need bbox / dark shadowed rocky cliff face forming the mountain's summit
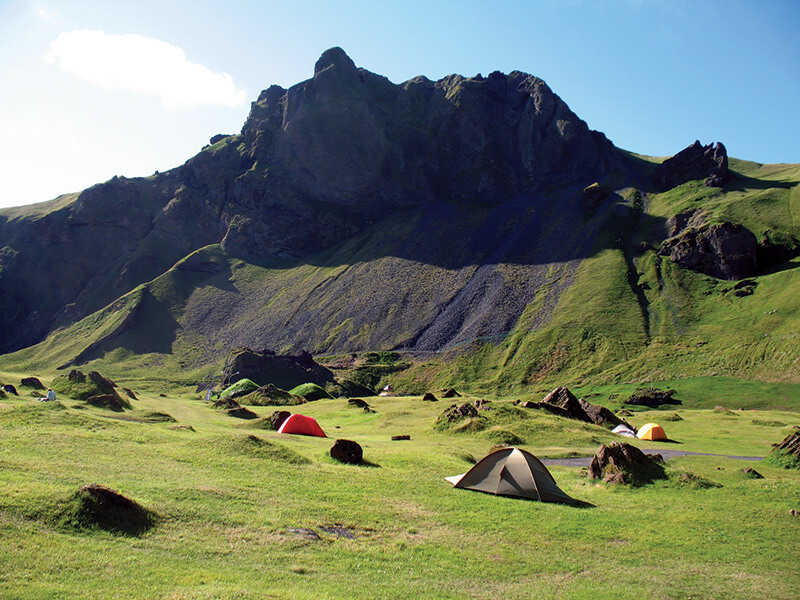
[0,48,622,353]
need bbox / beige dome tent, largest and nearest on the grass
[445,448,575,503]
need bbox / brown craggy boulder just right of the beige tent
[589,442,666,485]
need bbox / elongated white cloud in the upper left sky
[45,30,246,109]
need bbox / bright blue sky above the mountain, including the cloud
[0,0,800,207]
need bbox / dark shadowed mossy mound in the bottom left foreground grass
[45,484,157,536]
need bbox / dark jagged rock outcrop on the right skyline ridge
[654,141,730,191]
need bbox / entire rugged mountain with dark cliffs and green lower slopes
[0,48,800,386]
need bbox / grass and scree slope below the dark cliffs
[0,160,800,393]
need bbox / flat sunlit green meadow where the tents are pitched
[0,374,800,600]
